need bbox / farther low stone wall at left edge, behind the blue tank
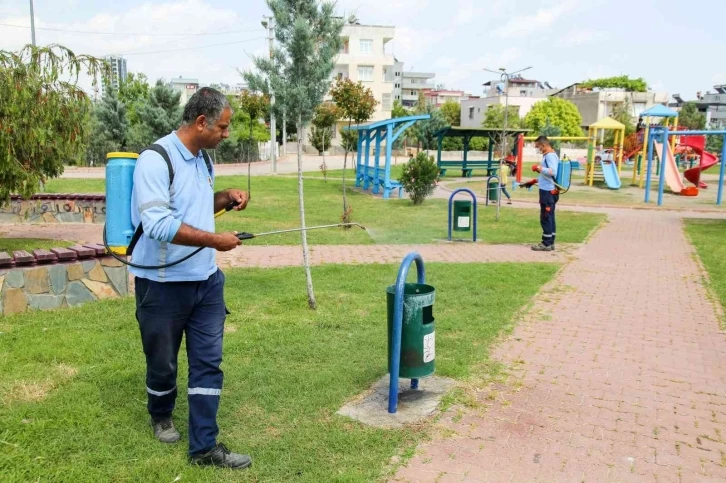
[0,193,106,225]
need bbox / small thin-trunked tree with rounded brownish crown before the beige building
[330,78,378,223]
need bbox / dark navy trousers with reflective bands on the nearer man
[136,270,227,454]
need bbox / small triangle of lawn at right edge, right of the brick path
[685,219,726,328]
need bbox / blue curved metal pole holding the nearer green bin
[388,251,426,414]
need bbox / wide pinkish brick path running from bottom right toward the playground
[396,211,726,483]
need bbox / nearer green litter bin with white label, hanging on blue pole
[386,283,436,379]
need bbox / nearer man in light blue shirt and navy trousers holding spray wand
[131,87,252,469]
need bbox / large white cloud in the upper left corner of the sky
[0,0,267,94]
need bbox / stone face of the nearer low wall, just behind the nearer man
[0,257,129,315]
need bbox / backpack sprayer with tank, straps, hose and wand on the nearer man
[103,151,366,270]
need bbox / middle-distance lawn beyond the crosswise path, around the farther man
[42,176,605,245]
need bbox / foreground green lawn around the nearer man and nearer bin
[0,263,557,483]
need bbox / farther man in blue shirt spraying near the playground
[521,136,560,252]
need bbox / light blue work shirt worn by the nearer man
[129,131,217,282]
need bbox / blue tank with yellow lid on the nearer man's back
[106,153,139,255]
